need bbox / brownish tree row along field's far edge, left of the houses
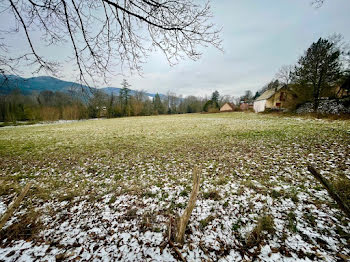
[0,80,245,122]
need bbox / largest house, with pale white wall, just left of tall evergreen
[254,85,296,113]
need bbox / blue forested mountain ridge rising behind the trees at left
[0,75,163,97]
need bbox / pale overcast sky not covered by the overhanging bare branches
[0,0,350,96]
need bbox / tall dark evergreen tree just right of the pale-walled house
[295,38,342,111]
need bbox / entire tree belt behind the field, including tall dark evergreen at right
[0,33,350,122]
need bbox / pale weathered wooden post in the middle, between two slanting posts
[175,169,200,244]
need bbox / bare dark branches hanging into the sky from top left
[0,0,221,83]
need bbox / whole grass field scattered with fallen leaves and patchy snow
[0,113,350,261]
